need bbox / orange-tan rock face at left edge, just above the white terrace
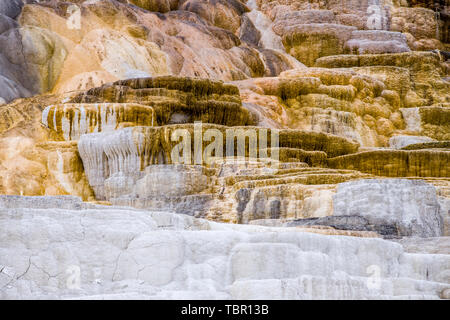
[0,91,94,200]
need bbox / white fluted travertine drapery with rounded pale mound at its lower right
[78,128,214,204]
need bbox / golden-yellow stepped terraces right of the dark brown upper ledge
[233,67,400,147]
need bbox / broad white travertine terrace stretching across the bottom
[0,197,450,299]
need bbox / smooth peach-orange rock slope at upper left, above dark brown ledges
[13,0,301,92]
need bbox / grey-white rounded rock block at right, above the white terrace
[333,179,444,237]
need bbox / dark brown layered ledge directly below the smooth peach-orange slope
[71,76,254,126]
